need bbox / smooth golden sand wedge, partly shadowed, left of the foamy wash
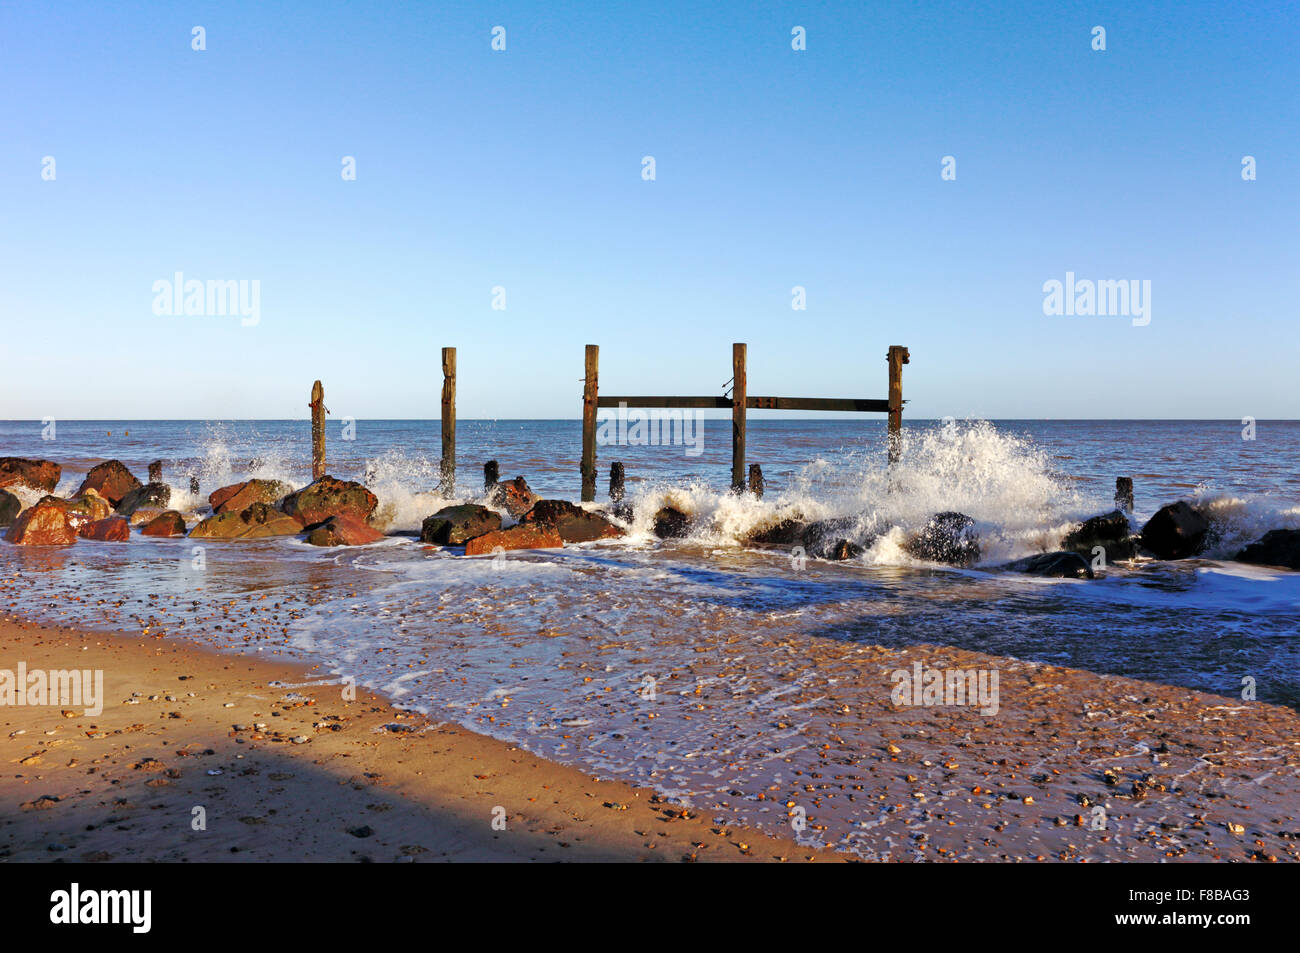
[0,616,841,863]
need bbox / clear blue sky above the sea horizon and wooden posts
[0,0,1300,419]
